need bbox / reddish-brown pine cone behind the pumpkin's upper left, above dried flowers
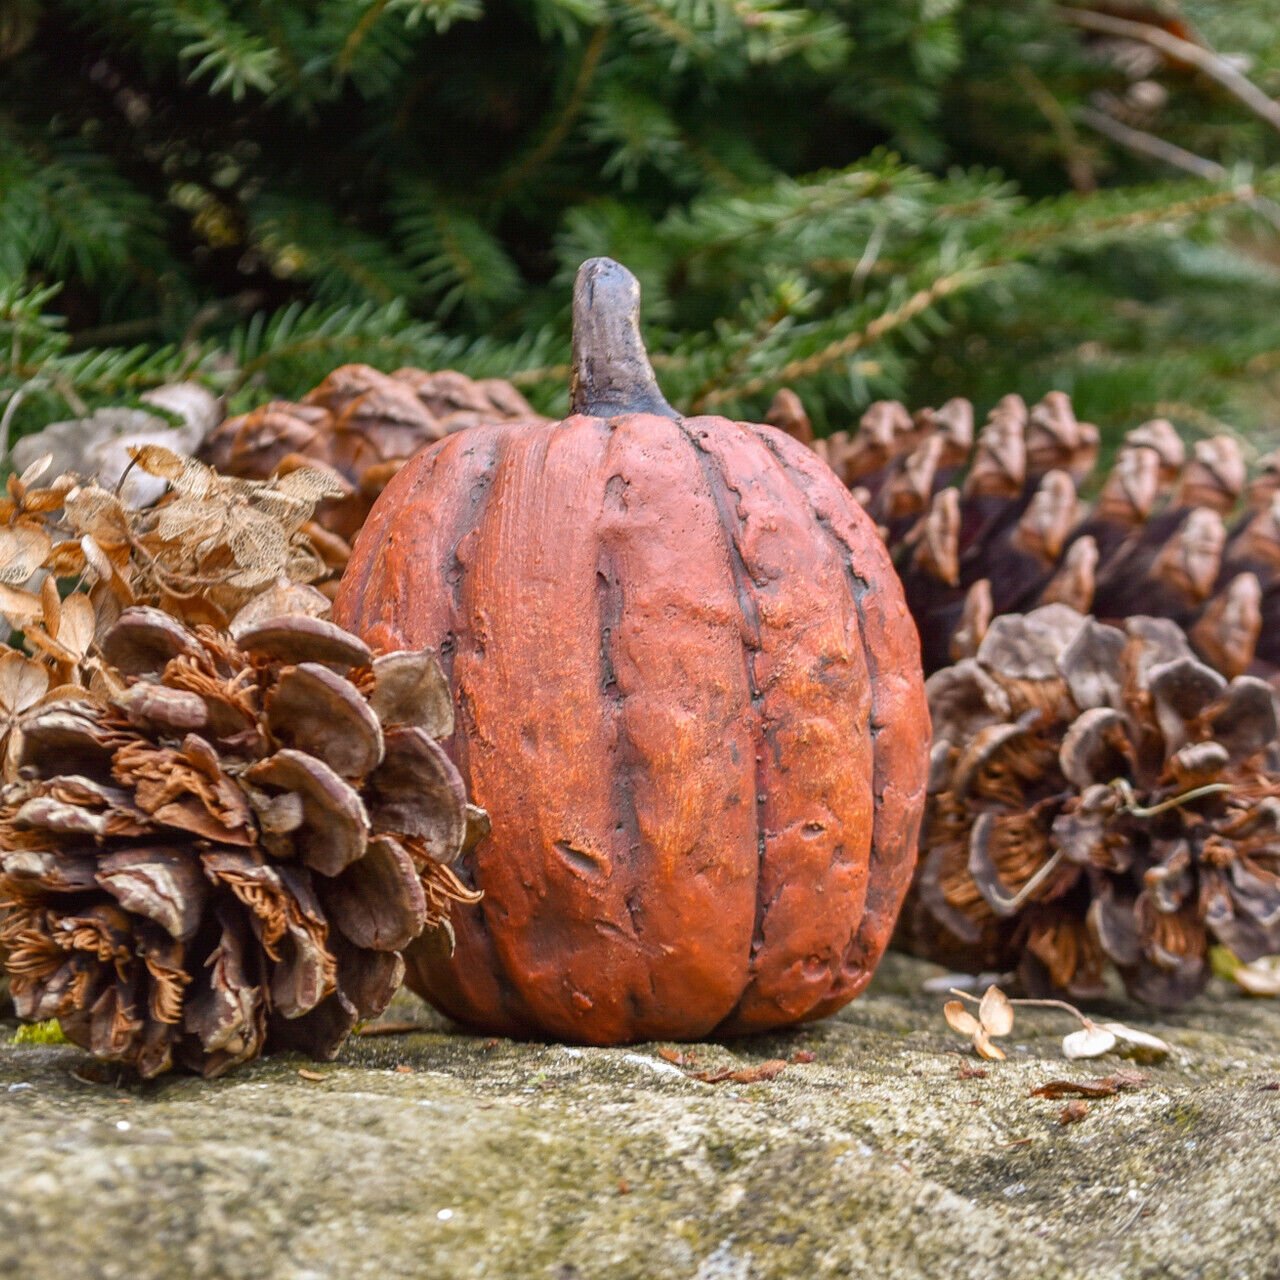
[204,365,538,542]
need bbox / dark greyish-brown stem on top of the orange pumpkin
[570,257,680,417]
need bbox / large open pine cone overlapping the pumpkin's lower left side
[0,608,481,1076]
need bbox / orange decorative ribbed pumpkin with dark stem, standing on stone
[335,259,929,1044]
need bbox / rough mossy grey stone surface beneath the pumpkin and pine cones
[0,956,1280,1280]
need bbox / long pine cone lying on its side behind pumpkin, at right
[769,392,1280,677]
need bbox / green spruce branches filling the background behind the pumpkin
[0,0,1280,448]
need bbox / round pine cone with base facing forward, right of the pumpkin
[897,604,1280,1006]
